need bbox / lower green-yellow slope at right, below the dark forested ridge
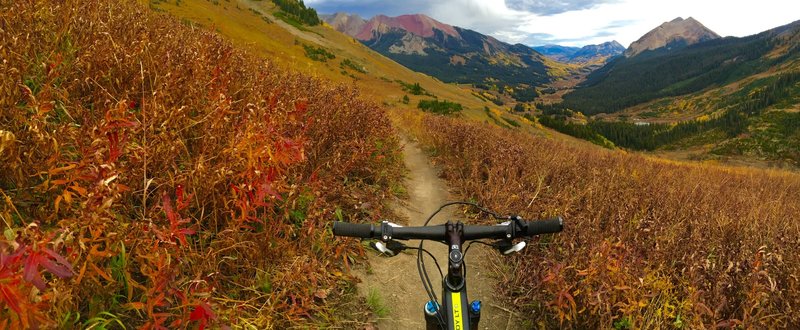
[538,69,800,169]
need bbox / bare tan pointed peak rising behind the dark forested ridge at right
[625,17,720,57]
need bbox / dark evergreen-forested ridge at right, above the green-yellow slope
[564,22,800,115]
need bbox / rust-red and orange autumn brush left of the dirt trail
[0,0,400,329]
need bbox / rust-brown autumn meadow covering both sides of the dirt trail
[6,0,800,329]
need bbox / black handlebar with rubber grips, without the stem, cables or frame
[333,217,564,241]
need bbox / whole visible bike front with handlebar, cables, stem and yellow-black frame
[333,201,564,330]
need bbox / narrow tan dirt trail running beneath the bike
[357,141,521,330]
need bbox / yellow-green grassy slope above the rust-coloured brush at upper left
[151,0,528,121]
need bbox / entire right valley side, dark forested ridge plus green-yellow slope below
[539,22,800,168]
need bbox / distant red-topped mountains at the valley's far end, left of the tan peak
[321,13,636,104]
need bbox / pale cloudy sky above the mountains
[305,0,800,47]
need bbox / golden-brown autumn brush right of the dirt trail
[397,112,800,329]
